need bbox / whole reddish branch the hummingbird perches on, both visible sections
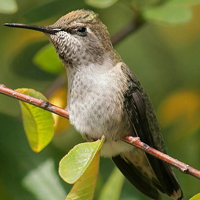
[0,84,200,179]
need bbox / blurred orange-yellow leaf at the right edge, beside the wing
[158,90,200,142]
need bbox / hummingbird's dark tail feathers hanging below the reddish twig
[112,152,183,200]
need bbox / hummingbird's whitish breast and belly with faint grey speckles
[67,63,128,141]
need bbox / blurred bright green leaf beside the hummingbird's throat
[33,44,64,74]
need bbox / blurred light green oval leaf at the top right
[142,4,192,24]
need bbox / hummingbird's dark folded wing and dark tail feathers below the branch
[113,65,183,199]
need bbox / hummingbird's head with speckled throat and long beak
[4,10,113,66]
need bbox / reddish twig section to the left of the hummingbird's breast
[0,84,69,119]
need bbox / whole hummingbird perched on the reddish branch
[4,9,183,200]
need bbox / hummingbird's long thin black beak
[4,23,61,34]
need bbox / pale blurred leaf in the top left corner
[0,0,18,14]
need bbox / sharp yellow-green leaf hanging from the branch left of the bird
[16,88,54,152]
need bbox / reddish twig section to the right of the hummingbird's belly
[123,136,200,179]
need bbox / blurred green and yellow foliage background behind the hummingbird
[0,0,200,200]
